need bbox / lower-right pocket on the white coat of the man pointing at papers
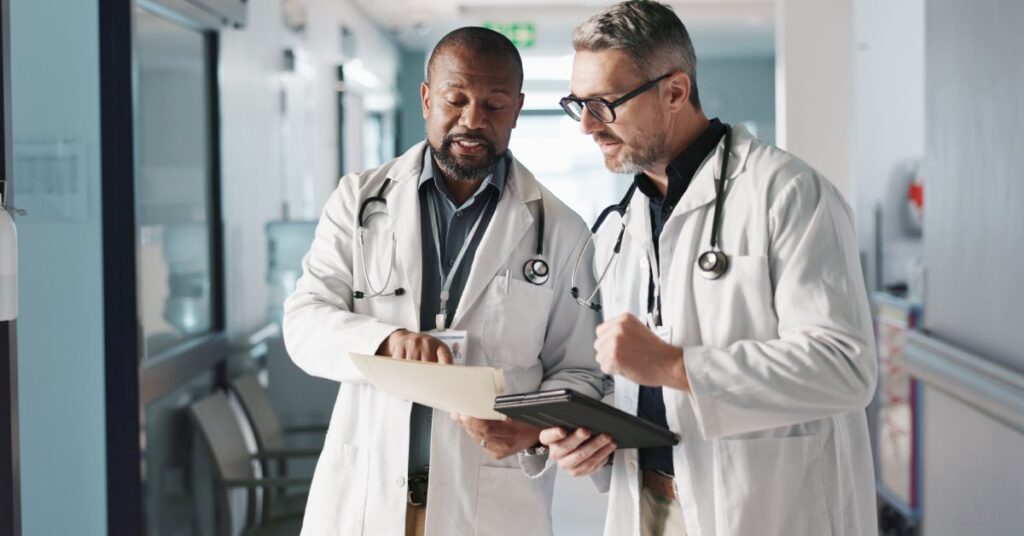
[476,465,556,536]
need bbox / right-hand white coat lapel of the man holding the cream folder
[452,159,541,328]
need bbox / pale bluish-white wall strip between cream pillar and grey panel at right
[850,0,925,288]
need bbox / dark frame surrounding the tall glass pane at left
[99,0,229,536]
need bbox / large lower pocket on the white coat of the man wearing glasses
[715,436,834,536]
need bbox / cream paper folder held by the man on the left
[348,354,507,420]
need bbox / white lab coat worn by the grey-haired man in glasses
[595,127,877,536]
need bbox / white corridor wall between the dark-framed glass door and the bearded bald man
[220,0,398,337]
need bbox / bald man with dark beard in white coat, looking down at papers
[284,28,605,536]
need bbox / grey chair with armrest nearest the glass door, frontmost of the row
[188,393,309,536]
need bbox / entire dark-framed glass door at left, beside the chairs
[99,0,229,535]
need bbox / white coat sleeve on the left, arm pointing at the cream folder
[283,177,400,382]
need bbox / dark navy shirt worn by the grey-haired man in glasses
[635,119,727,475]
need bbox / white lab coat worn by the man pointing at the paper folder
[284,143,604,536]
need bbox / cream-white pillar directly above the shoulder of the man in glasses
[774,0,851,199]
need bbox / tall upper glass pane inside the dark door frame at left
[135,9,213,356]
